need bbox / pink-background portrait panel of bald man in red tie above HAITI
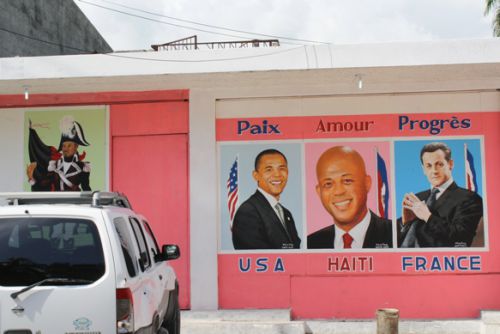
[305,141,394,251]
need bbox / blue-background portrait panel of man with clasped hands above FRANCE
[394,138,486,248]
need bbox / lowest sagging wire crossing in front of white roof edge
[0,28,302,63]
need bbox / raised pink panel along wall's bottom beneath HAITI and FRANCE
[290,274,500,319]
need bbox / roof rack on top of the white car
[0,191,132,209]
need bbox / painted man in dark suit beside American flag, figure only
[232,149,300,249]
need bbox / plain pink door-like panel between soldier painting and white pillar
[110,101,190,308]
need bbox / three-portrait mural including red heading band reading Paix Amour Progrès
[217,114,487,253]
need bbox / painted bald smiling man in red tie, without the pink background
[307,146,392,248]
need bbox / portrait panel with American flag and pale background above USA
[219,143,305,250]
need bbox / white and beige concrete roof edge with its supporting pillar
[0,39,500,310]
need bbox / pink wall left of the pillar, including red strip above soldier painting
[0,90,190,308]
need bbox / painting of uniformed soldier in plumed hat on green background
[25,107,106,191]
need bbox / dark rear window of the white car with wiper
[0,217,105,286]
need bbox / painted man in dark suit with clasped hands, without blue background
[398,143,483,248]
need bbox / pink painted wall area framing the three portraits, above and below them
[217,112,500,319]
